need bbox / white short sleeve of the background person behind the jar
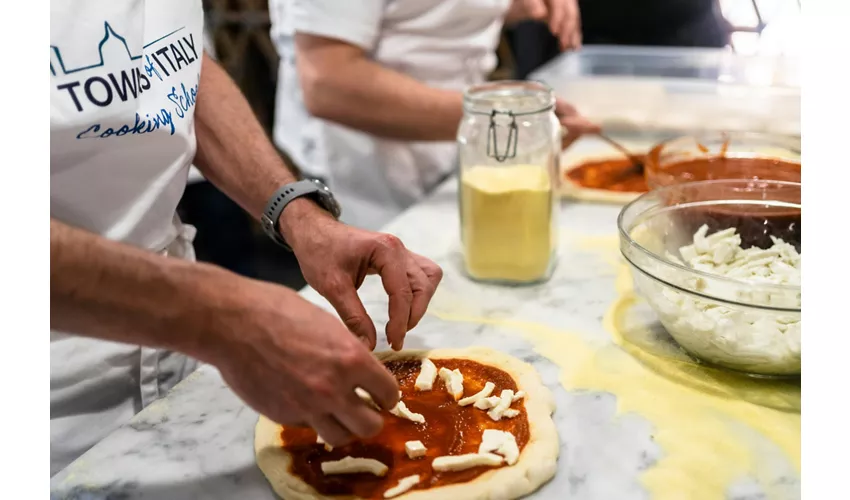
[291,0,386,50]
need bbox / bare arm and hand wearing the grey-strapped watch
[185,52,444,348]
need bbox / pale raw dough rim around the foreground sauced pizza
[254,347,560,500]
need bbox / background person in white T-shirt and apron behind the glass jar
[269,0,596,229]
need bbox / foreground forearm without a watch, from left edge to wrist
[50,219,235,359]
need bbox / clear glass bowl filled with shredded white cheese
[617,180,801,376]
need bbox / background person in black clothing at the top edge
[508,0,730,80]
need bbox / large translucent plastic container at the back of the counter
[530,46,800,136]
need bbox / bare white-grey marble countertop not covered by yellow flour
[50,180,799,500]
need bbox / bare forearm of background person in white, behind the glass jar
[295,33,463,141]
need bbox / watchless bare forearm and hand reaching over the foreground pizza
[50,219,398,446]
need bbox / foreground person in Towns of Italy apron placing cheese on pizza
[50,0,442,476]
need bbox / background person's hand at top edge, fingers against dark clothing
[505,0,581,50]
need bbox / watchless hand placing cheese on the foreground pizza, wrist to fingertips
[207,278,398,446]
